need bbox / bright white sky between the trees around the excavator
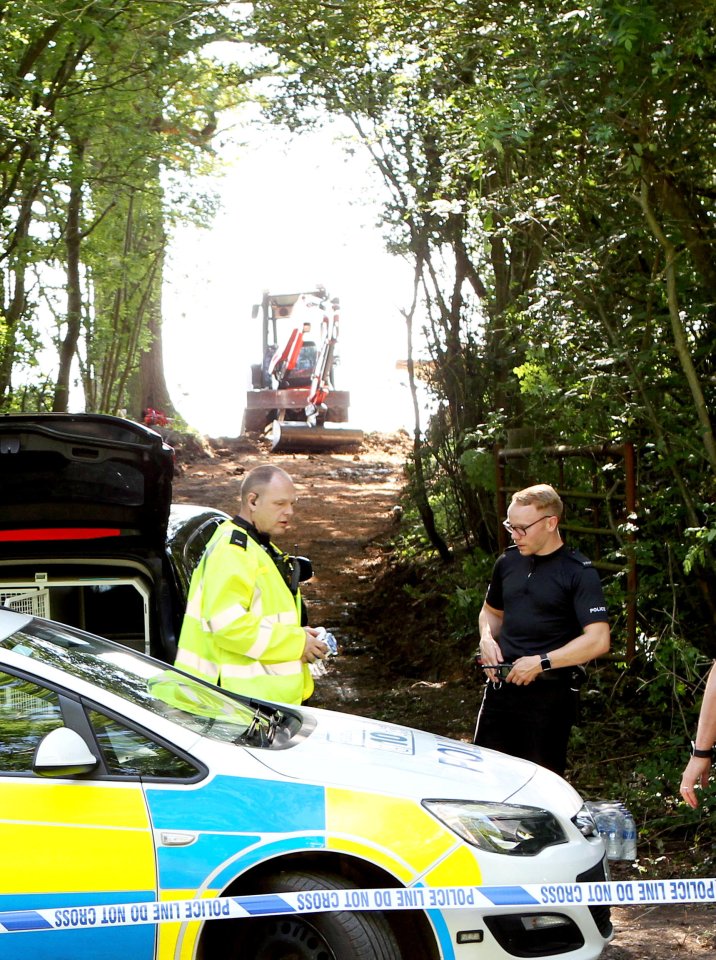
[164,113,426,436]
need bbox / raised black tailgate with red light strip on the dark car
[0,413,174,553]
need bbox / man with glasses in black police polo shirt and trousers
[475,483,610,775]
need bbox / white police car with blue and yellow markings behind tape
[0,609,612,960]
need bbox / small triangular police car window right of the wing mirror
[88,710,199,780]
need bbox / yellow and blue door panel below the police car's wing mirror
[0,777,156,960]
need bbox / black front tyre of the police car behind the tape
[233,872,402,960]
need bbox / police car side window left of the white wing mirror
[0,673,63,774]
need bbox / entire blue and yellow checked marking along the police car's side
[0,775,481,960]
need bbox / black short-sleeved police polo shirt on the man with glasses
[486,545,608,661]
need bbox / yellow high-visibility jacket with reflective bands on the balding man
[175,520,313,704]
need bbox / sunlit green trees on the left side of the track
[0,0,246,412]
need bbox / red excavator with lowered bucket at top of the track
[242,287,363,452]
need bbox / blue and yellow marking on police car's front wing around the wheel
[147,776,481,958]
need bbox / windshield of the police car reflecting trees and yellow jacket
[0,619,266,743]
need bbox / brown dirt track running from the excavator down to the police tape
[168,434,716,960]
